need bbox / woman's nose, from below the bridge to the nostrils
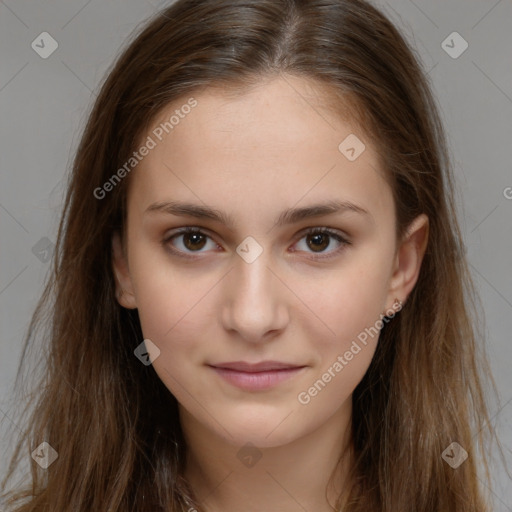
[222,251,289,343]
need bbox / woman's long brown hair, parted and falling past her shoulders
[2,0,504,512]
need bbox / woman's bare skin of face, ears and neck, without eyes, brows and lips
[113,77,428,512]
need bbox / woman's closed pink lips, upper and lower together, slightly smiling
[208,361,306,391]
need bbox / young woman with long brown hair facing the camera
[0,0,500,512]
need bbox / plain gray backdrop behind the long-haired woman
[0,0,512,511]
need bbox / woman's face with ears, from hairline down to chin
[114,78,426,447]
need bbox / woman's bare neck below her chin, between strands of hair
[180,399,352,512]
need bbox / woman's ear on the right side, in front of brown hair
[388,213,429,308]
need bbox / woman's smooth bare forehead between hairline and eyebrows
[129,77,391,226]
